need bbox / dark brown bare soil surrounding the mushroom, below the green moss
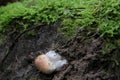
[0,23,120,80]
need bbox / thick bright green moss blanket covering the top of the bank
[0,0,120,37]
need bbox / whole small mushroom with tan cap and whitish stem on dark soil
[35,51,67,74]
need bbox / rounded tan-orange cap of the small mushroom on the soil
[35,54,55,74]
